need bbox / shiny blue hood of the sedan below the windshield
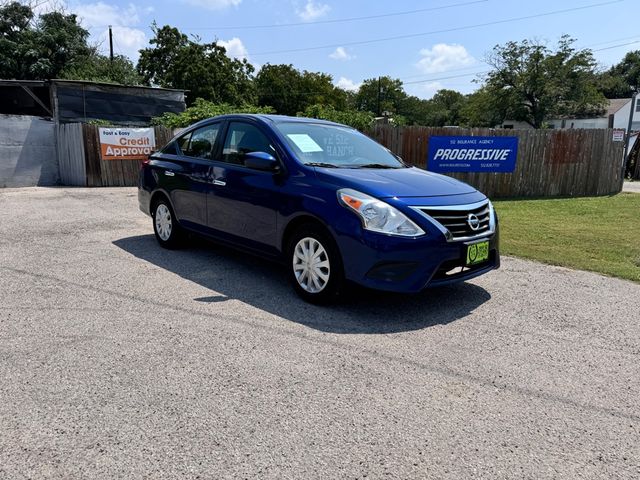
[316,167,477,198]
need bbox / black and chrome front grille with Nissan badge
[417,202,491,240]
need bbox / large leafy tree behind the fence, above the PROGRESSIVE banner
[485,36,606,128]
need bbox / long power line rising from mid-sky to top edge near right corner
[251,0,625,56]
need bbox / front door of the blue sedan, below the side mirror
[207,120,282,253]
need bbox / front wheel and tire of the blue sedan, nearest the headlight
[286,224,344,303]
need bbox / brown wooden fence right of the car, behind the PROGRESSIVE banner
[367,125,624,198]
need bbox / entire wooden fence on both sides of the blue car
[57,123,624,197]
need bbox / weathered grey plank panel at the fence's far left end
[56,123,87,187]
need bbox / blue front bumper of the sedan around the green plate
[338,221,500,293]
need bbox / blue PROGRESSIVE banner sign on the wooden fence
[427,137,518,173]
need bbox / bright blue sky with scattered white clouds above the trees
[40,0,640,98]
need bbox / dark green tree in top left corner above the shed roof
[0,2,93,80]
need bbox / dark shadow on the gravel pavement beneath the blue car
[113,235,491,334]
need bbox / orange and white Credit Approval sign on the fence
[98,128,156,160]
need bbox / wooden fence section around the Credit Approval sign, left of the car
[57,123,173,187]
